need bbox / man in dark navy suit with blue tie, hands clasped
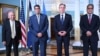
[54,4,73,56]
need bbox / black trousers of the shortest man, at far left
[6,39,18,56]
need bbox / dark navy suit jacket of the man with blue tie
[54,14,73,36]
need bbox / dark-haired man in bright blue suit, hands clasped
[29,5,48,56]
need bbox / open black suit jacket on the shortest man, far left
[2,18,21,44]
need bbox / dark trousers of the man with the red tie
[83,40,98,56]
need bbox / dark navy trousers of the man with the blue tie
[57,37,69,56]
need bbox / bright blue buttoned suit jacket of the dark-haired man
[29,14,48,41]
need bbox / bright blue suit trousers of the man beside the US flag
[32,40,47,56]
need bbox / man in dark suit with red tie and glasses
[80,4,100,56]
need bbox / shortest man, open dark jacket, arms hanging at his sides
[2,11,21,56]
